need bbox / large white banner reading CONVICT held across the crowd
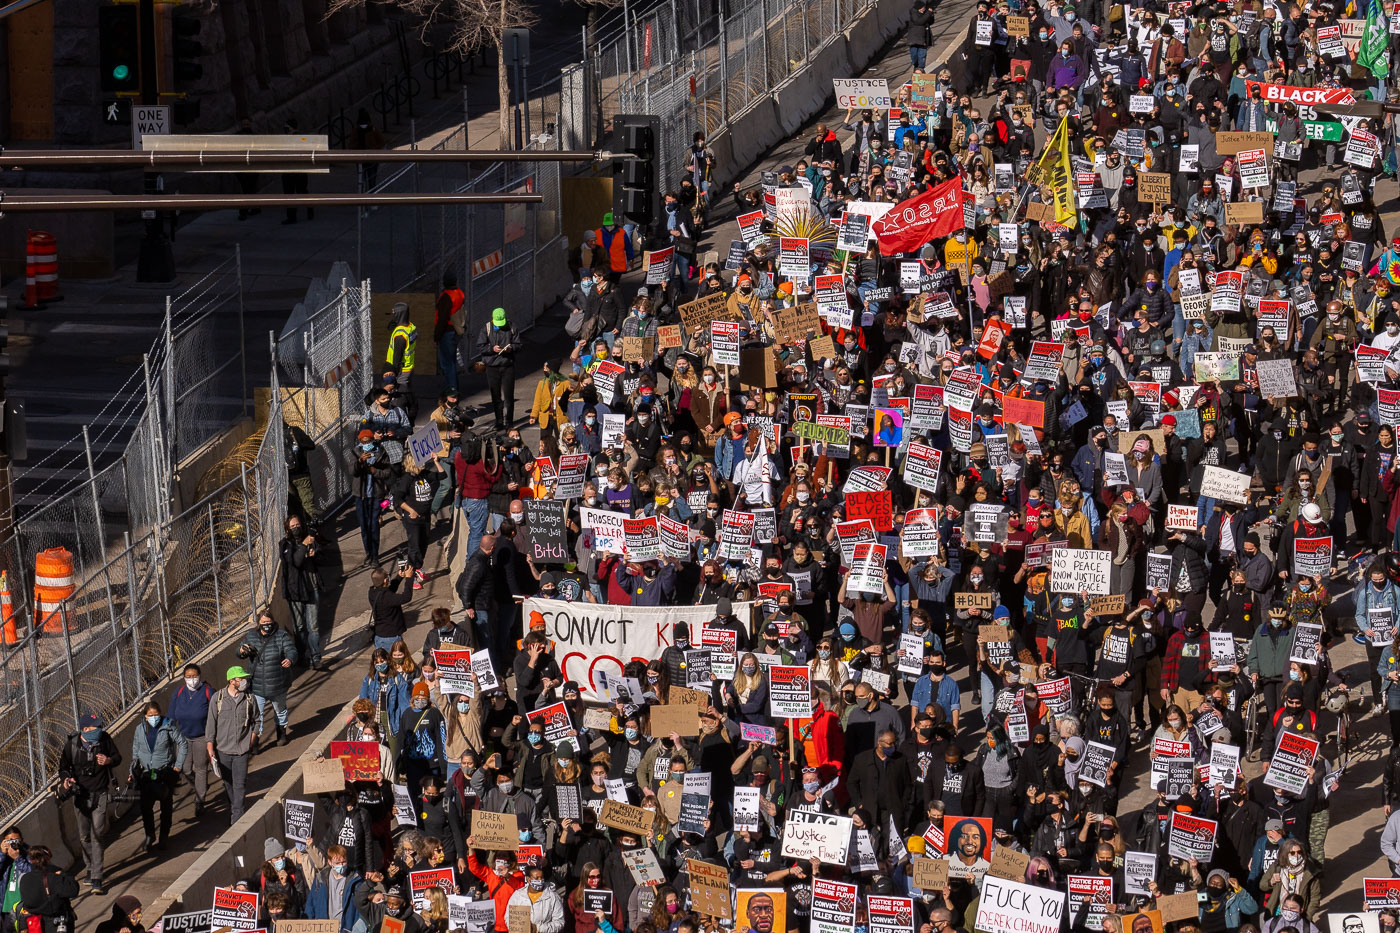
[522,597,749,696]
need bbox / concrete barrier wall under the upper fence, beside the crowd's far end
[707,0,910,189]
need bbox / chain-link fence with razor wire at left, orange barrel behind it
[0,264,372,821]
